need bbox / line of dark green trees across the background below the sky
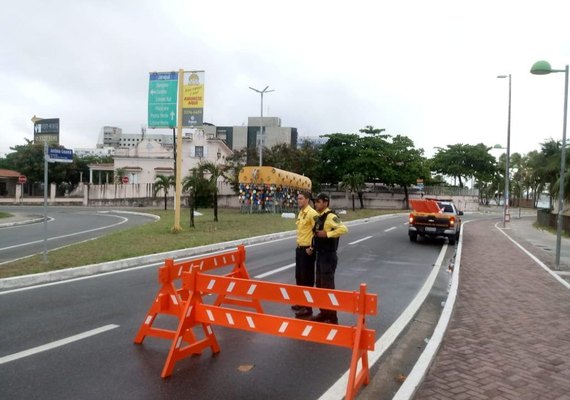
[0,132,570,212]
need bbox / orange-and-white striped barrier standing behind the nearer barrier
[134,245,263,344]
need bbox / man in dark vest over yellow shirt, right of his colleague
[311,193,348,324]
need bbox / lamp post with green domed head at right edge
[530,61,568,269]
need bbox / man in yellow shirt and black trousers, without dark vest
[291,191,318,318]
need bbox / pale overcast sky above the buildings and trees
[0,0,570,156]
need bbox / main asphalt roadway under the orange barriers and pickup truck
[0,215,451,400]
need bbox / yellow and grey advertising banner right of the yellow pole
[181,71,205,128]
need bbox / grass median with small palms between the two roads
[0,209,401,278]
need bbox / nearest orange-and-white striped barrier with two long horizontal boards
[161,271,378,399]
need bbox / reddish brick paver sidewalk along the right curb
[414,221,570,400]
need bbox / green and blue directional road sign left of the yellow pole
[148,72,178,128]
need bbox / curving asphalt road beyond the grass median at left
[0,207,153,263]
